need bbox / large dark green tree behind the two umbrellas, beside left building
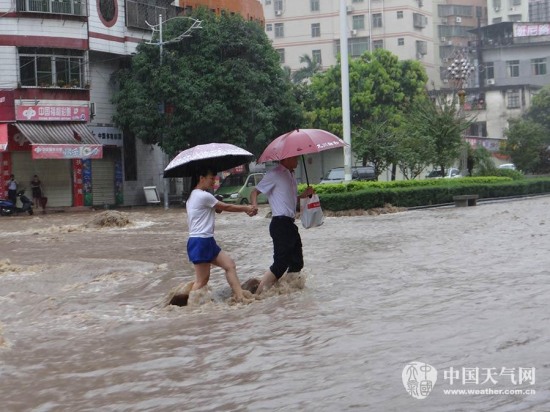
[114,9,302,155]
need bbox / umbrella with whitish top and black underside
[164,143,254,177]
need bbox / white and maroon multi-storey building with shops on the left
[0,0,263,206]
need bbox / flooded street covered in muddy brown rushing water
[0,196,550,411]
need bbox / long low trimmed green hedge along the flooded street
[300,177,550,211]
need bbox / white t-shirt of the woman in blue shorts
[185,189,218,237]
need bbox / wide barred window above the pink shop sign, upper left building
[19,47,85,88]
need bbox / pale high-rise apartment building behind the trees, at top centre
[262,0,439,84]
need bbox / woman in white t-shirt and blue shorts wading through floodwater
[186,169,258,301]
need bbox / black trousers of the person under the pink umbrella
[269,216,304,279]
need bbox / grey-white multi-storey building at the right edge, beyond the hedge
[465,22,550,151]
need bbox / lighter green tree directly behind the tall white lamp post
[304,49,427,175]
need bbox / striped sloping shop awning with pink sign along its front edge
[14,122,103,159]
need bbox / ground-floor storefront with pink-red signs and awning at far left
[0,91,108,207]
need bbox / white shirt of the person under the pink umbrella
[256,165,298,217]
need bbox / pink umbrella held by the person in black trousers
[258,129,348,184]
